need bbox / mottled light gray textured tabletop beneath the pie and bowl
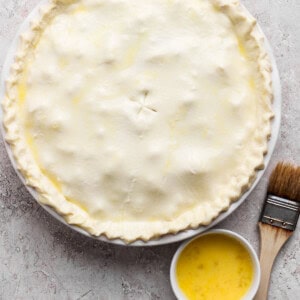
[0,0,300,300]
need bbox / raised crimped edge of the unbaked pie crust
[3,0,273,243]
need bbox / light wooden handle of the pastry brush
[255,223,293,300]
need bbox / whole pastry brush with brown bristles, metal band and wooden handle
[255,162,300,300]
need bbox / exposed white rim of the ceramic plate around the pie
[0,0,281,246]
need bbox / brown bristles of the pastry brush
[268,162,300,201]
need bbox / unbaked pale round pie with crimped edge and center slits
[3,0,273,242]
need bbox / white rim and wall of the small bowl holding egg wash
[170,229,261,300]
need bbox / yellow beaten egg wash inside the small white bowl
[176,234,254,300]
